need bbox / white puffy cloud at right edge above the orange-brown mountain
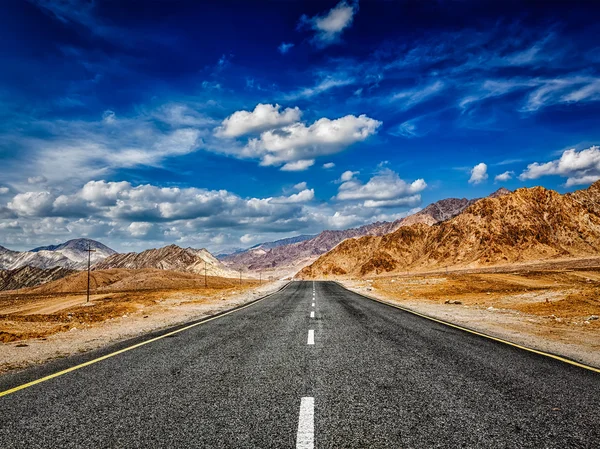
[519,145,600,187]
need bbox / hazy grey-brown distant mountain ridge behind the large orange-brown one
[221,194,477,276]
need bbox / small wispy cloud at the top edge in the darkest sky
[300,1,358,47]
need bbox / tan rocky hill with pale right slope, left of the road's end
[93,245,239,277]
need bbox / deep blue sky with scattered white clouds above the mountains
[0,0,600,251]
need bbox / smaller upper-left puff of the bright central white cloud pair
[215,103,302,137]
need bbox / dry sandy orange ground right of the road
[342,260,600,367]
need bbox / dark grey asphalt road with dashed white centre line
[0,282,600,448]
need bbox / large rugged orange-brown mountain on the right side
[299,181,600,278]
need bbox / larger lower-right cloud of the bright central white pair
[245,115,381,170]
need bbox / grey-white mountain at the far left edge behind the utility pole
[0,239,115,270]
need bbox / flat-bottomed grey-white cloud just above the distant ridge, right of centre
[335,169,427,208]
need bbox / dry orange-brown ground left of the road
[0,269,281,373]
